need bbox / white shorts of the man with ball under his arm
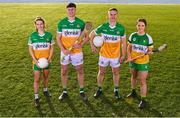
[99,56,120,68]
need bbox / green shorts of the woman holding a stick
[129,62,150,71]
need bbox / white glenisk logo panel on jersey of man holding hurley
[62,29,81,37]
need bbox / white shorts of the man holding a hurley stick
[60,51,83,66]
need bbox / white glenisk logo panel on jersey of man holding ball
[102,34,120,42]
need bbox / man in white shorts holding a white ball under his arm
[90,8,126,99]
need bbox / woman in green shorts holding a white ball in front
[28,17,54,106]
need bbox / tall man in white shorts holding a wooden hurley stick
[57,3,88,101]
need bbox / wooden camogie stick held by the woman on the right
[125,44,167,63]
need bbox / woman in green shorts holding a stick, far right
[127,19,153,108]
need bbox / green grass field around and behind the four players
[0,4,180,117]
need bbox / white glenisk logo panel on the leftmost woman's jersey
[33,43,50,50]
